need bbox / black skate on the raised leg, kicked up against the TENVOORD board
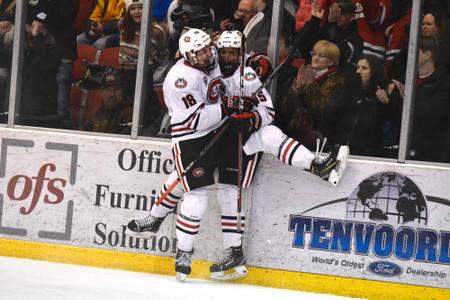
[310,138,350,186]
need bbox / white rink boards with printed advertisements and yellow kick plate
[0,128,450,299]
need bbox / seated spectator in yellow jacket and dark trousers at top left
[77,0,124,50]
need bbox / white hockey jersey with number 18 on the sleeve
[163,59,225,142]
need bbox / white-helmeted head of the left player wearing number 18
[178,28,217,69]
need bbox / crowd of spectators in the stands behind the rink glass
[0,0,450,162]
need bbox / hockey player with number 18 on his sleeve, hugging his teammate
[159,29,264,281]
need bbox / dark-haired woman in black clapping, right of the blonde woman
[334,54,401,157]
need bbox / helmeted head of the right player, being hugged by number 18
[217,30,242,76]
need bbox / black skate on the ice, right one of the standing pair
[209,246,247,280]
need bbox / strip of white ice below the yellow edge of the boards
[0,257,358,300]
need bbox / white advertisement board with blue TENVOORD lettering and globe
[248,156,450,288]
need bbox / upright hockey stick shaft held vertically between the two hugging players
[236,34,245,233]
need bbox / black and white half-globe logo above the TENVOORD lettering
[346,172,428,225]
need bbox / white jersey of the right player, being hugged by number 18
[222,67,275,127]
